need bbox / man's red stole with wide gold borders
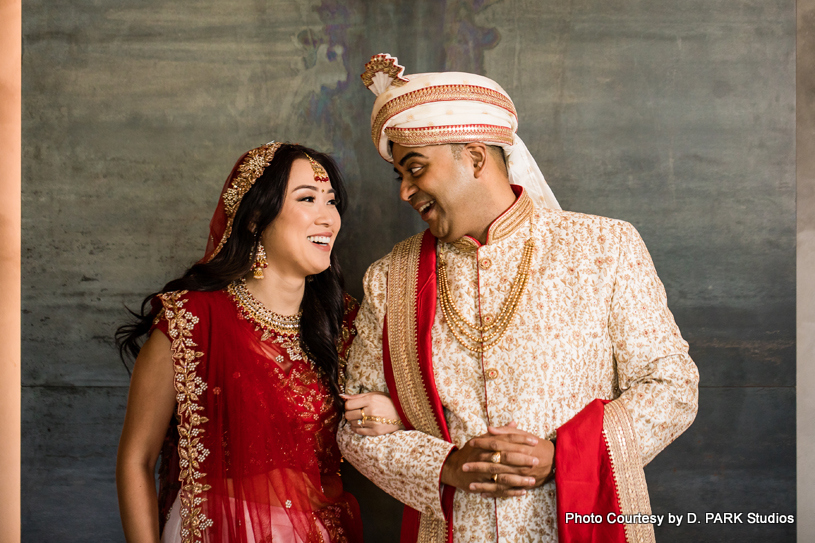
[382,230,654,543]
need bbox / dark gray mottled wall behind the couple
[22,0,796,542]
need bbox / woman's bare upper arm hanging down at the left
[116,331,176,543]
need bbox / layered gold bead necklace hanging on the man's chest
[437,237,535,353]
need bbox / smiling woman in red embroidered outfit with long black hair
[116,142,401,543]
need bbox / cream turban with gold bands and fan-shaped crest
[362,54,560,209]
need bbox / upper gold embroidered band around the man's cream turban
[371,85,518,149]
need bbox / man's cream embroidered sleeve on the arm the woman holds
[337,257,453,519]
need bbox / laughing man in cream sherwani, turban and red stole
[339,55,698,542]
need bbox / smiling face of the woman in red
[261,158,341,278]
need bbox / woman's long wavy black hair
[116,144,347,396]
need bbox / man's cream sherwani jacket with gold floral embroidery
[338,189,698,543]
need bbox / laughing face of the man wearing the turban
[392,143,478,243]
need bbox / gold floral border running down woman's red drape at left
[159,290,212,543]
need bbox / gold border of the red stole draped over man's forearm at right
[603,400,656,543]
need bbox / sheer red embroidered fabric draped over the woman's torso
[154,290,362,543]
